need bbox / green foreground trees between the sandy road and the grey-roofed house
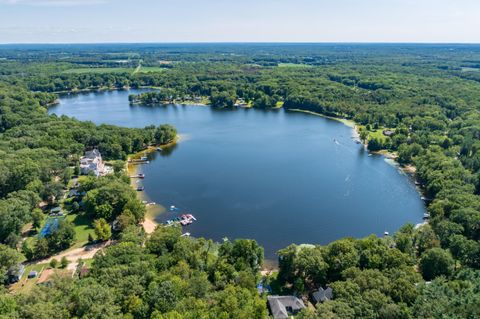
[0,226,267,319]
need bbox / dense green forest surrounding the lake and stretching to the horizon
[0,44,480,318]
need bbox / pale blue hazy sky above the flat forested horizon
[0,0,480,43]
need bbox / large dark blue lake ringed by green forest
[49,90,425,259]
